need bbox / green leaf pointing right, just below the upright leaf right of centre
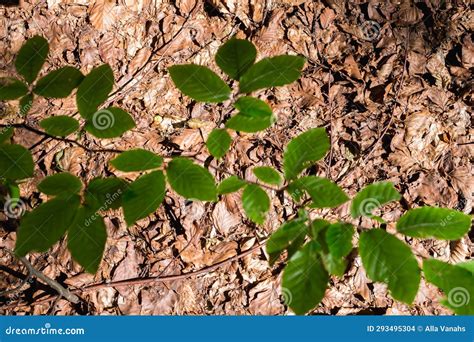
[288,176,349,208]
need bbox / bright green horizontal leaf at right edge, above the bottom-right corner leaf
[397,207,471,240]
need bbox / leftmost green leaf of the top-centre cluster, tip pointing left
[168,64,230,102]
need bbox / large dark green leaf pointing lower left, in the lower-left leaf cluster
[15,195,80,256]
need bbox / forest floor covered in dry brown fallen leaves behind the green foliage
[0,0,474,315]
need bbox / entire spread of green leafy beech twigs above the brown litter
[0,37,474,314]
